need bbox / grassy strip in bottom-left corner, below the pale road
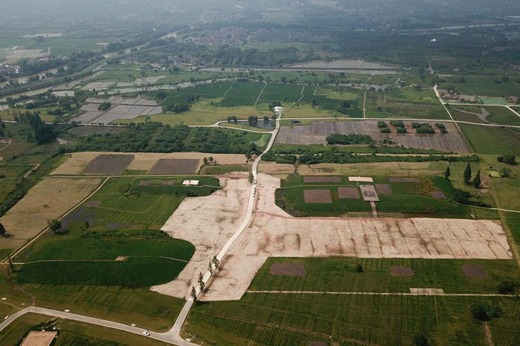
[0,314,165,346]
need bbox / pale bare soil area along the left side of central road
[151,173,252,298]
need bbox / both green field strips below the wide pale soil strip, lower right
[186,258,520,345]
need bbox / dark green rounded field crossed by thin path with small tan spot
[15,228,195,288]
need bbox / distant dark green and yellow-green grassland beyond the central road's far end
[119,80,363,125]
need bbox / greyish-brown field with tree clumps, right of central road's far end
[276,120,471,153]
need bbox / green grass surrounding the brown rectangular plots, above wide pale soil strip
[276,175,476,218]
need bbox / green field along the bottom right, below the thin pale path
[185,294,520,345]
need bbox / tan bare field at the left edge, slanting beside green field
[0,177,101,253]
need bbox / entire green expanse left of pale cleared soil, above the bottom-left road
[0,176,219,330]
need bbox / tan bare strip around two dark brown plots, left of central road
[51,152,246,175]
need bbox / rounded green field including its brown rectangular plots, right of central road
[275,175,476,218]
